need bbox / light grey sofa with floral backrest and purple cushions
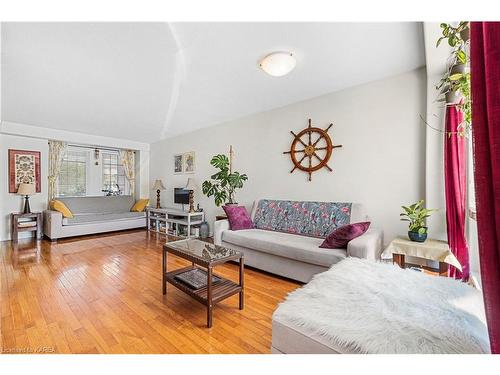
[214,200,383,283]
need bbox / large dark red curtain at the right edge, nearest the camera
[470,22,500,354]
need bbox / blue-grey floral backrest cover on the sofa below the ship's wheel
[253,199,351,238]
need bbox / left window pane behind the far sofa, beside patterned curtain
[58,148,87,197]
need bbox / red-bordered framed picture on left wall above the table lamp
[9,149,42,193]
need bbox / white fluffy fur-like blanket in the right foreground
[273,258,490,353]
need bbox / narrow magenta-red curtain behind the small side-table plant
[444,105,469,281]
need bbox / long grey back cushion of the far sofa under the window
[57,195,135,215]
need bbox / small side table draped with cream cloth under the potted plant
[382,237,462,276]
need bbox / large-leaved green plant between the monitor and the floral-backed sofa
[202,154,248,207]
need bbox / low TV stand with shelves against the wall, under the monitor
[146,207,205,238]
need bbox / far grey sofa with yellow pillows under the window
[43,195,146,240]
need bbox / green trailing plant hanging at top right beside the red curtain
[436,21,472,136]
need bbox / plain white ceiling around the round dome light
[2,23,425,142]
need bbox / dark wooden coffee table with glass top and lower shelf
[162,239,244,328]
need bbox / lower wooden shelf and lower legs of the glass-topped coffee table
[164,266,243,328]
